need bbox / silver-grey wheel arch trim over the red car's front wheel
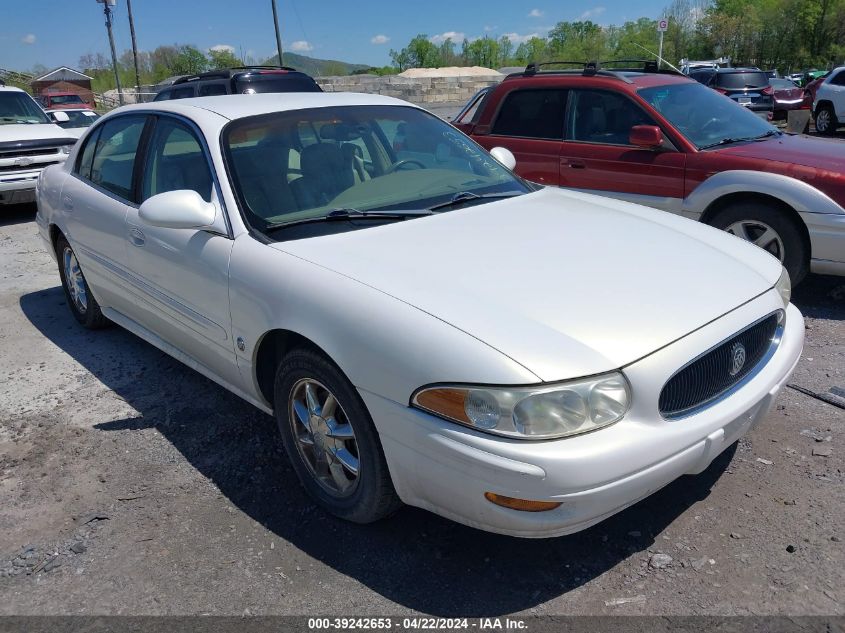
[683,169,845,219]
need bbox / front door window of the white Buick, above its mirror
[141,117,212,202]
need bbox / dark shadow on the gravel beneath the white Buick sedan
[20,287,736,616]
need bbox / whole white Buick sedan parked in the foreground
[38,94,804,537]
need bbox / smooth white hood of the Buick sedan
[274,188,781,381]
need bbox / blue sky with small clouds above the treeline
[0,0,668,70]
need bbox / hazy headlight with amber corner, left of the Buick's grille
[411,372,631,440]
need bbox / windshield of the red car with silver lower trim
[638,83,776,149]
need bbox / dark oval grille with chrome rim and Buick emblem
[658,312,783,418]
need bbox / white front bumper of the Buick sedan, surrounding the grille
[361,291,804,538]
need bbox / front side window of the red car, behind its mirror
[567,90,656,145]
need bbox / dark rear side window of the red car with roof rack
[492,90,568,140]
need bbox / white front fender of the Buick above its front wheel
[229,235,540,404]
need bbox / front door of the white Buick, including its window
[124,117,240,384]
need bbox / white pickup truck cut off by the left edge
[0,85,76,205]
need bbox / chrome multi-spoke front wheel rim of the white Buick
[289,378,360,498]
